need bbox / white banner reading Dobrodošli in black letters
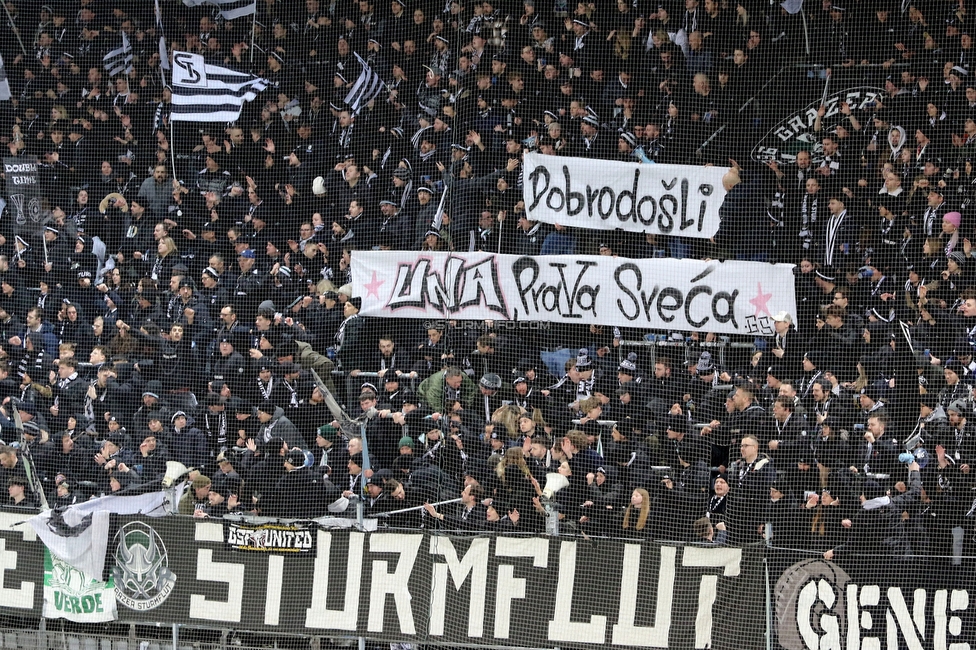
[522,153,729,239]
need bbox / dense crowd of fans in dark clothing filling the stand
[0,0,976,557]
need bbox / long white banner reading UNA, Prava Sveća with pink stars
[352,251,796,336]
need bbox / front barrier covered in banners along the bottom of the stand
[0,510,976,650]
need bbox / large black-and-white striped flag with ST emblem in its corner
[170,52,268,122]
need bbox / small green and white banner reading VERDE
[44,549,118,623]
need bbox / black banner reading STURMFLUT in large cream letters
[0,517,764,650]
